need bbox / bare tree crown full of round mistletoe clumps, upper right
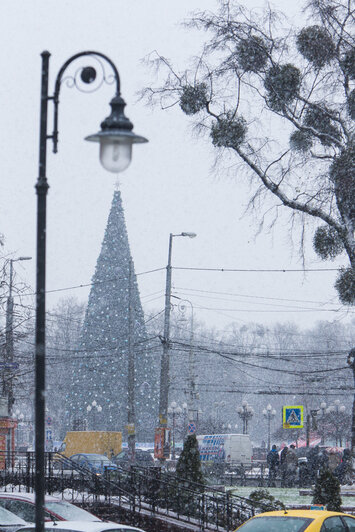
[145,0,355,305]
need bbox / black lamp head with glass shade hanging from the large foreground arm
[85,96,148,173]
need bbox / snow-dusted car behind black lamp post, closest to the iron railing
[0,492,101,526]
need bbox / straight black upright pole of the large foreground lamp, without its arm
[35,52,50,532]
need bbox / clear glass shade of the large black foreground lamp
[100,137,132,173]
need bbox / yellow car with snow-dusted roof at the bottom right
[237,510,355,532]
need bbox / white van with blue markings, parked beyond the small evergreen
[197,434,252,466]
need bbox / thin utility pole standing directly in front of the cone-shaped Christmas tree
[127,258,136,464]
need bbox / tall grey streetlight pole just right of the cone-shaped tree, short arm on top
[159,232,197,434]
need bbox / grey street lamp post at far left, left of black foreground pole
[3,257,32,417]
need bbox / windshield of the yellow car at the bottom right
[240,515,313,532]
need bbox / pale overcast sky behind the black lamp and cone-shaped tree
[0,0,351,329]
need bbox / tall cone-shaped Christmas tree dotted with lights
[68,191,158,441]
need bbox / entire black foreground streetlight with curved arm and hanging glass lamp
[35,51,147,532]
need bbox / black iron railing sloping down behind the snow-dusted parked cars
[0,452,273,531]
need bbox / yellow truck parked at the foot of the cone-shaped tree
[58,430,122,458]
